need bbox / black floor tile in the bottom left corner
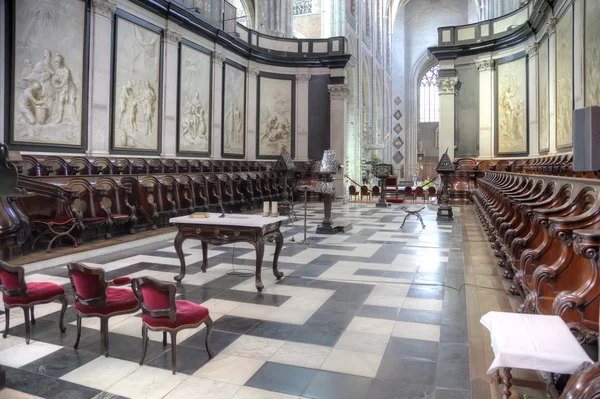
[4,366,100,399]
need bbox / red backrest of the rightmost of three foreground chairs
[132,277,177,321]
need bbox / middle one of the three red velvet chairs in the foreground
[67,263,140,357]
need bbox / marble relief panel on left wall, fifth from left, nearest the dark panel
[257,76,294,157]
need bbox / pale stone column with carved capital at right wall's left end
[437,76,459,159]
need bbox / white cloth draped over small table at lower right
[480,312,593,374]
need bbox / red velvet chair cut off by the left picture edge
[0,261,67,344]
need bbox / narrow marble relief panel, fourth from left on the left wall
[222,62,246,157]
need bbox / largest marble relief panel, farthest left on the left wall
[12,0,86,146]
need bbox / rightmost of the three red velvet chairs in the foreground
[132,277,215,374]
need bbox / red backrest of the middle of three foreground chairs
[67,262,108,306]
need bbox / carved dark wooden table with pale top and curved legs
[169,213,287,292]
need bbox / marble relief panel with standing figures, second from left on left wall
[112,17,162,151]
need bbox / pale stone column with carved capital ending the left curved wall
[327,84,350,198]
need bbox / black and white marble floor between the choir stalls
[0,203,470,399]
